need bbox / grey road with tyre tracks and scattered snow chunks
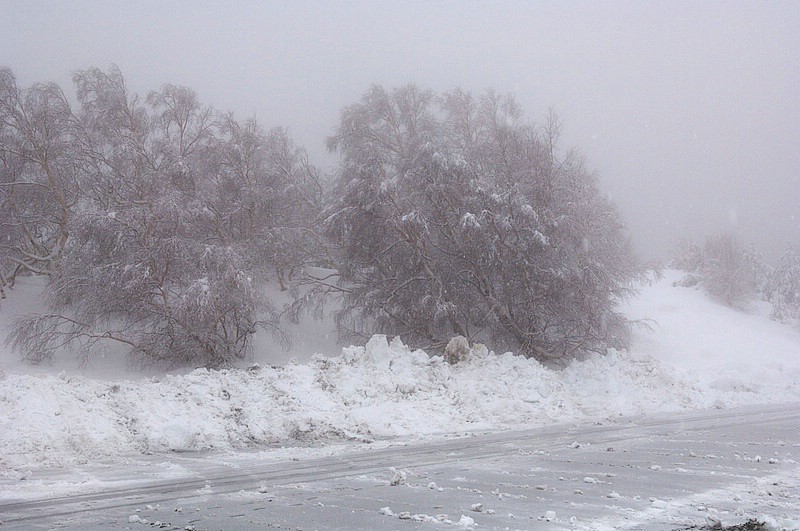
[0,404,800,529]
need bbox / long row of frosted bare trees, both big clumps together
[0,67,641,367]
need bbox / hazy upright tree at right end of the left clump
[203,115,322,289]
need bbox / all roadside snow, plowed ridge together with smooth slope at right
[0,272,800,474]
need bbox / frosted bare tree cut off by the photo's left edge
[0,68,83,298]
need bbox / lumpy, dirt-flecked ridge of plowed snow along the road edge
[0,336,800,470]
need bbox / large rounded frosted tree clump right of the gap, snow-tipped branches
[326,85,638,359]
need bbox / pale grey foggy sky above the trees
[0,0,800,260]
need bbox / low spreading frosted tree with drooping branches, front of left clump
[12,196,270,367]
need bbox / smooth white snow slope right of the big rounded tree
[627,271,800,403]
